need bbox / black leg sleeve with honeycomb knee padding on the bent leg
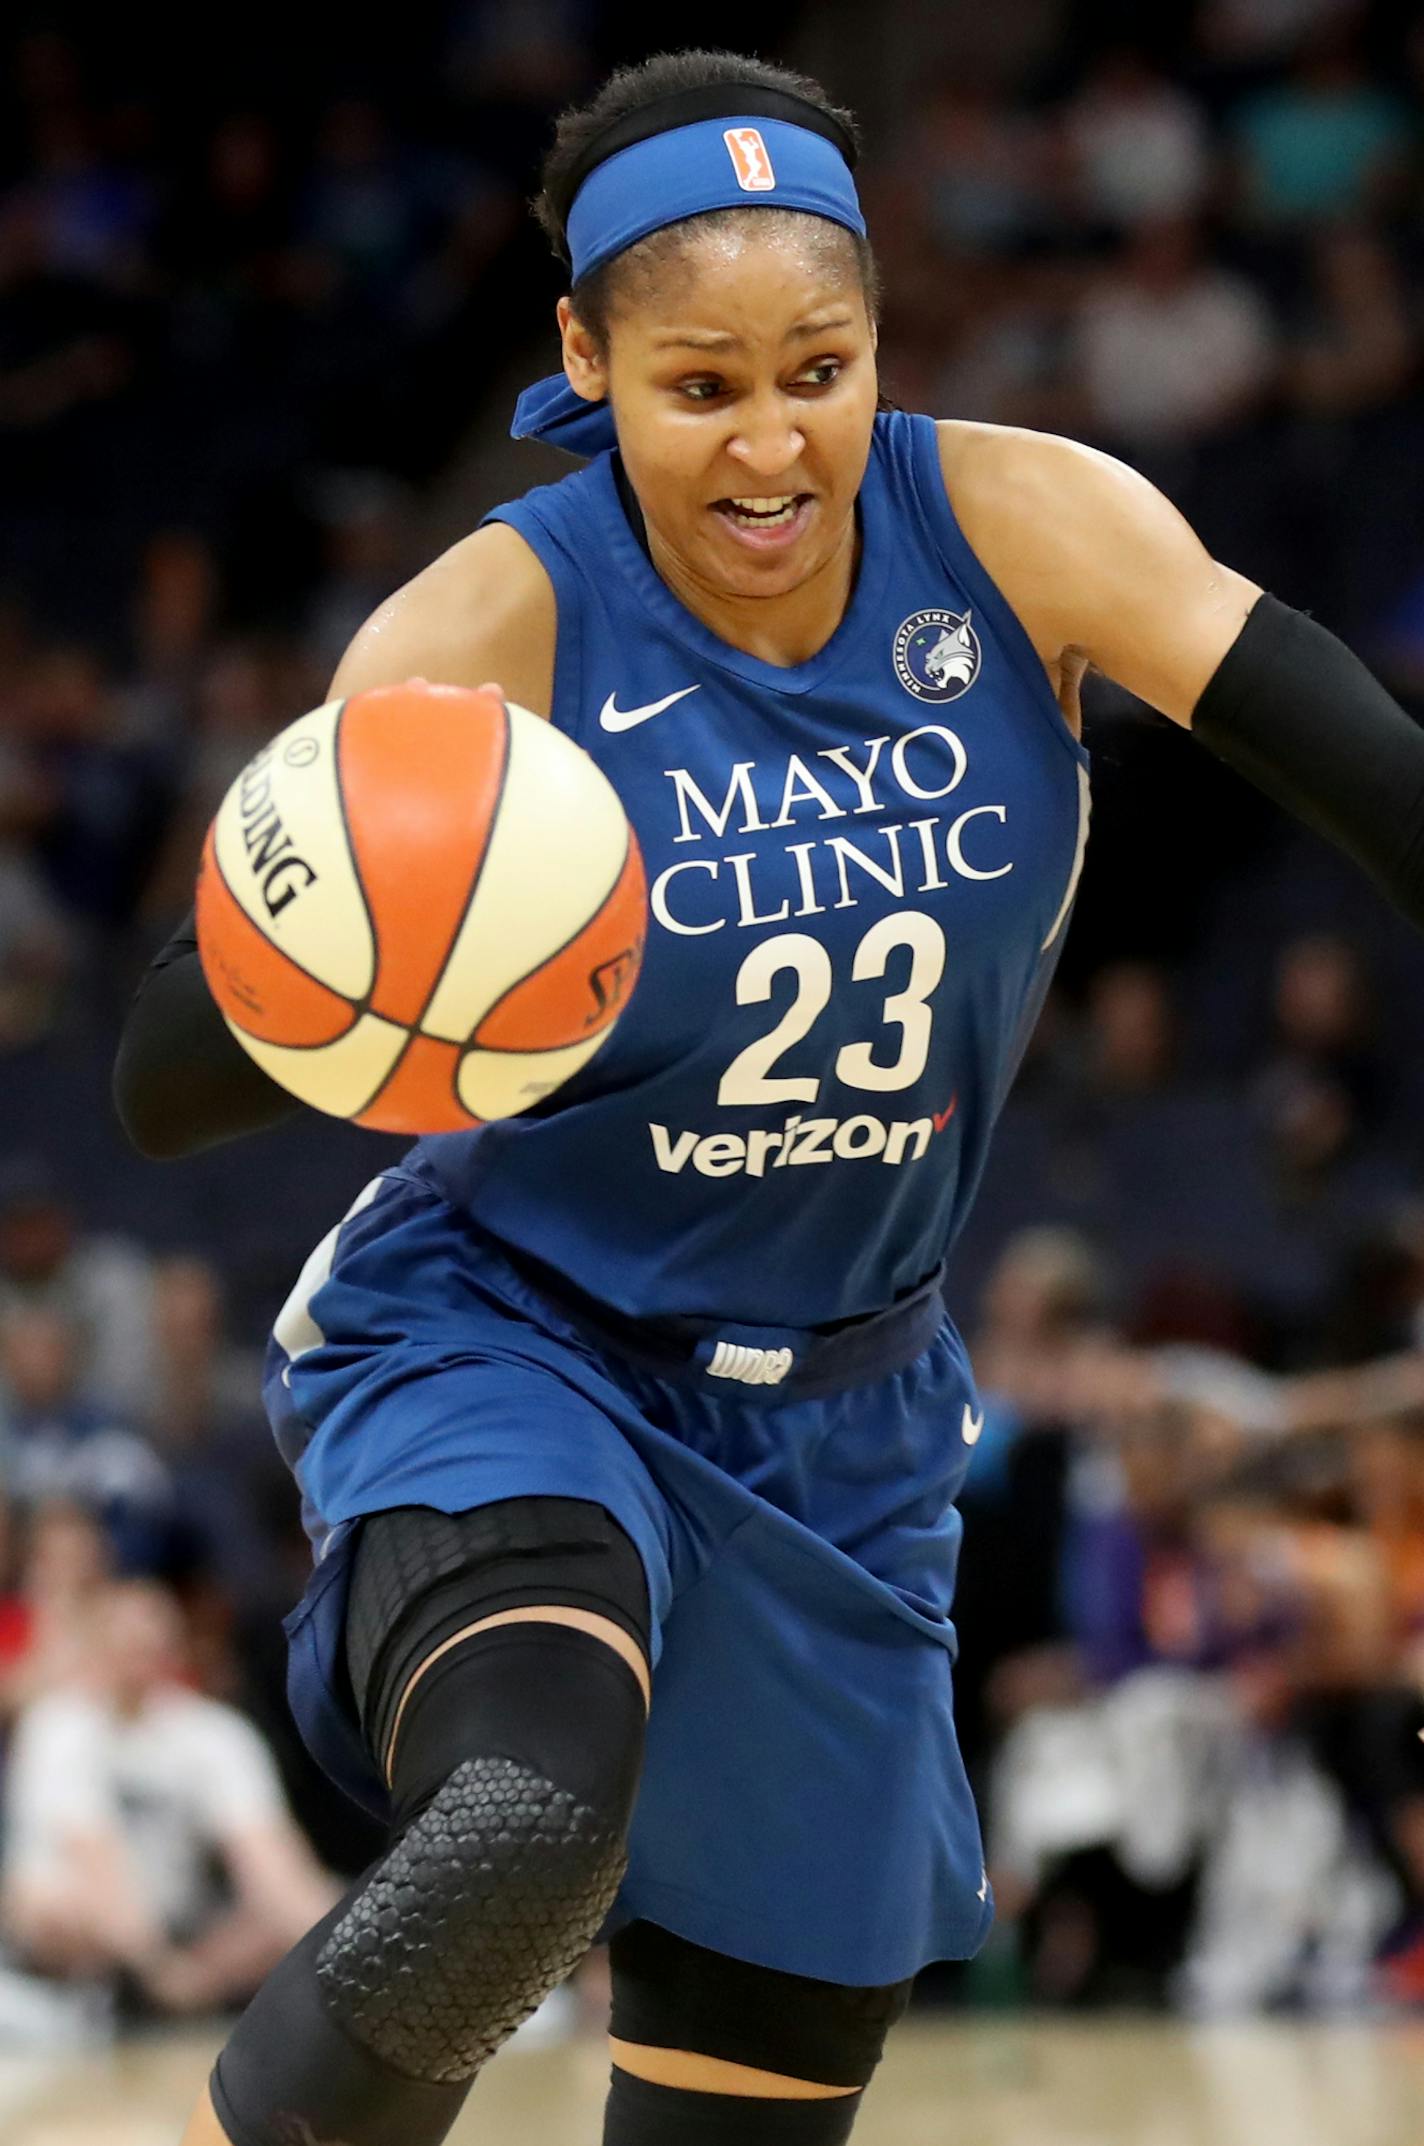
[212,1622,643,2146]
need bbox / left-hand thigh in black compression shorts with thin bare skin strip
[345,1496,652,1770]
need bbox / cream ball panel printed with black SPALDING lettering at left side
[212,700,375,998]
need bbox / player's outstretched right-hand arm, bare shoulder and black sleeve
[941,425,1424,927]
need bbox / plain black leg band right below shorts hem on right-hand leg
[609,1923,914,2086]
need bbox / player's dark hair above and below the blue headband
[532,52,879,348]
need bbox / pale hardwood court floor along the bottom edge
[0,2019,1424,2146]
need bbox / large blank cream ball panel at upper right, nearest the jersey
[420,706,628,1038]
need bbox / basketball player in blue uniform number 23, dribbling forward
[116,54,1424,2146]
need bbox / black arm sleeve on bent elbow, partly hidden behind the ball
[114,910,307,1161]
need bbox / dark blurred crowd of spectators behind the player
[0,0,1424,2039]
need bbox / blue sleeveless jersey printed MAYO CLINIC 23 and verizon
[418,412,1087,1328]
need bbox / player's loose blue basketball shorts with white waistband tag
[266,1163,993,1985]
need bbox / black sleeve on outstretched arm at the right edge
[1192,597,1424,929]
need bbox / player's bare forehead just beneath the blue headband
[615,210,866,341]
